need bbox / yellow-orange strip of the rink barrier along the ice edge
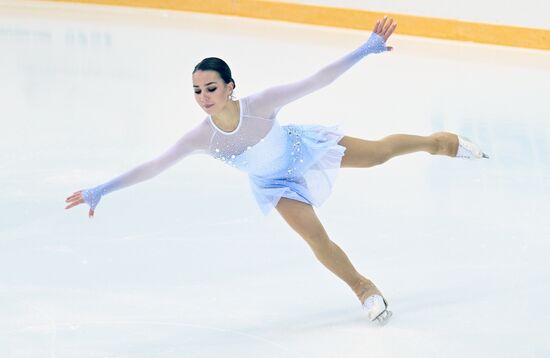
[46,0,550,50]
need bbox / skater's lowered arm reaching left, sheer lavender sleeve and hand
[65,121,211,218]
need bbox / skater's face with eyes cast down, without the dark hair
[193,70,234,115]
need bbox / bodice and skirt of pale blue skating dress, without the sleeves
[209,98,345,214]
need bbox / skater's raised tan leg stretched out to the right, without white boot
[339,132,458,168]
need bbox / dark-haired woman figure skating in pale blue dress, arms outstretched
[66,16,486,323]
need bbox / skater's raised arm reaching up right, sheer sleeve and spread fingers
[251,17,397,113]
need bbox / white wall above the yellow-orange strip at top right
[286,0,550,29]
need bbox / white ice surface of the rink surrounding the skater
[0,2,550,358]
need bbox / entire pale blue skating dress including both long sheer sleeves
[83,33,386,214]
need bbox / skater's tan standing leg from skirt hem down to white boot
[277,198,381,303]
